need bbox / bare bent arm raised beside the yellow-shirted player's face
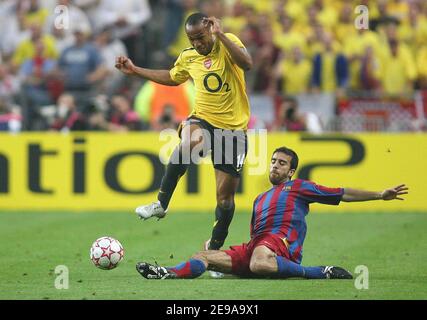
[204,17,252,70]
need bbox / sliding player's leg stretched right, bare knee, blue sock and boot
[249,246,353,279]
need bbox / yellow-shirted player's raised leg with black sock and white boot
[135,124,203,220]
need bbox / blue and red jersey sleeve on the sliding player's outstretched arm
[299,181,344,205]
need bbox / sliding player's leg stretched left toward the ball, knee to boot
[136,251,231,279]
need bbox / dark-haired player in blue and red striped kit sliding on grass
[136,147,408,279]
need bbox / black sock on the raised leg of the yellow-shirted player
[157,147,189,210]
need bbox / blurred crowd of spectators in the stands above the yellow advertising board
[0,0,427,132]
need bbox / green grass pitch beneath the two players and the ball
[0,212,427,300]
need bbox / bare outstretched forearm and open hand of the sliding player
[342,184,408,202]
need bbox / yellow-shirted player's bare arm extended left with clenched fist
[116,56,179,86]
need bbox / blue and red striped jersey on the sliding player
[251,179,344,263]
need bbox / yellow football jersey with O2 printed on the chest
[170,33,250,130]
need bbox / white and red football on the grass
[90,237,125,270]
